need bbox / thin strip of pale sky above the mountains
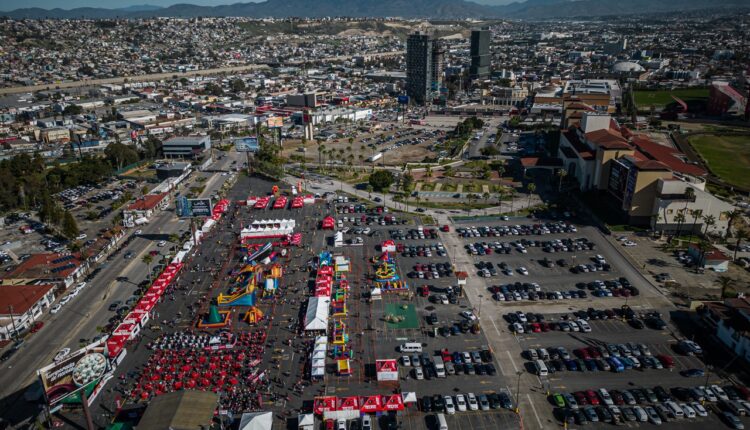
[0,0,517,11]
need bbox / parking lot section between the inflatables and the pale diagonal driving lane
[327,203,518,429]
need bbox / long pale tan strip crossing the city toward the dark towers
[0,51,404,96]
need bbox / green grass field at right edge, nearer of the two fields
[690,134,750,189]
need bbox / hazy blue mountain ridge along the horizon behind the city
[0,0,748,19]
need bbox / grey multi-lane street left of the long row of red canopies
[0,152,243,416]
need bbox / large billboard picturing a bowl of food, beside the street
[37,340,112,406]
